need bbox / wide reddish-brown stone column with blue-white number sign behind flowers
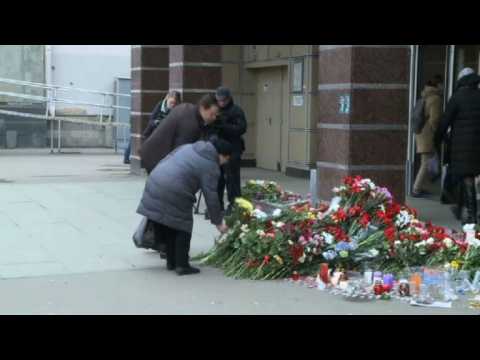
[315,45,410,201]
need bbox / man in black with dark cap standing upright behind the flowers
[209,87,247,212]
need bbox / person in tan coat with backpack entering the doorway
[412,75,443,197]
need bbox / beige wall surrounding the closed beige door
[222,45,318,169]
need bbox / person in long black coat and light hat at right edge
[435,68,480,224]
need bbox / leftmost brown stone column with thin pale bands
[130,45,169,174]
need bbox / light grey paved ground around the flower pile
[0,150,478,314]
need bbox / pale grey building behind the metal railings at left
[0,45,131,148]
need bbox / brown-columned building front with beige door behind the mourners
[131,45,479,200]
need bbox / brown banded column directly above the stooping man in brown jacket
[170,45,222,103]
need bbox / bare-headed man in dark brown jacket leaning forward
[140,95,219,174]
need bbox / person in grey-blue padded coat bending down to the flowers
[137,139,232,275]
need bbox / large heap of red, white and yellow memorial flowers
[196,176,480,280]
